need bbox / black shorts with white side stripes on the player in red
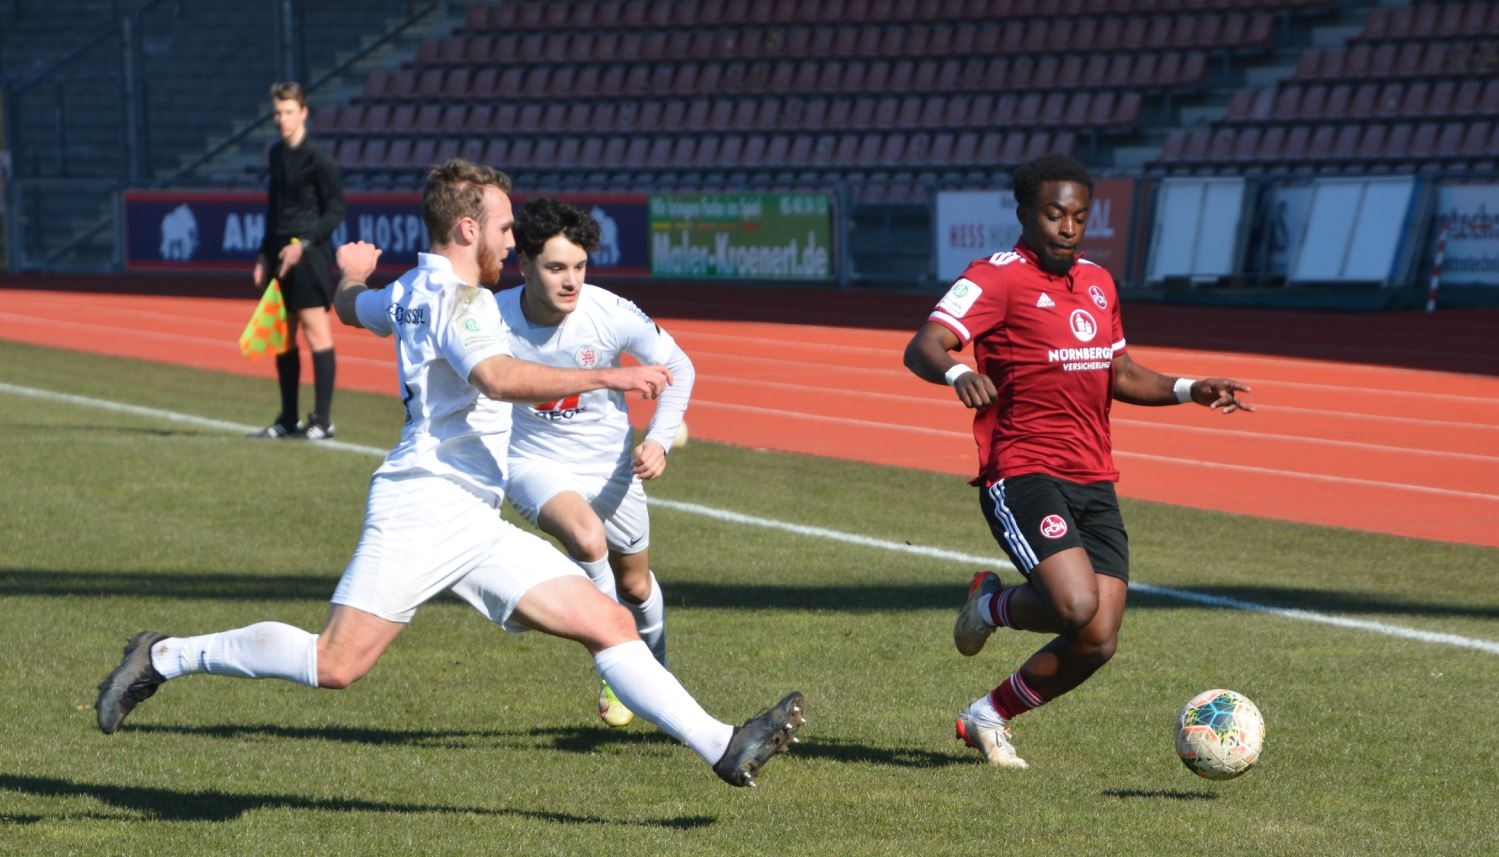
[979,473,1129,583]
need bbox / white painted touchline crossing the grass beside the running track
[0,382,1499,655]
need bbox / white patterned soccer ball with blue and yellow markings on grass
[1177,688,1265,779]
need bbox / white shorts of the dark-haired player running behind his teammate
[505,458,651,554]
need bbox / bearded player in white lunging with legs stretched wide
[94,160,802,785]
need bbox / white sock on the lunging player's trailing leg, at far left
[151,622,318,688]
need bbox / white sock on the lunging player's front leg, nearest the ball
[594,640,735,764]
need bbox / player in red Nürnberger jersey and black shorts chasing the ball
[905,154,1253,767]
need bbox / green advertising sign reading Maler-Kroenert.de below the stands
[651,193,833,280]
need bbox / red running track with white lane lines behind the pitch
[0,286,1499,547]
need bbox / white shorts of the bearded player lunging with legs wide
[333,476,583,631]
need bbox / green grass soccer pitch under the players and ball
[0,343,1499,857]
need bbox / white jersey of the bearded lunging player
[355,253,511,502]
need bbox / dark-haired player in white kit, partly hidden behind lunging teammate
[495,198,694,727]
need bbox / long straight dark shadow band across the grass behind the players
[11,569,1499,619]
